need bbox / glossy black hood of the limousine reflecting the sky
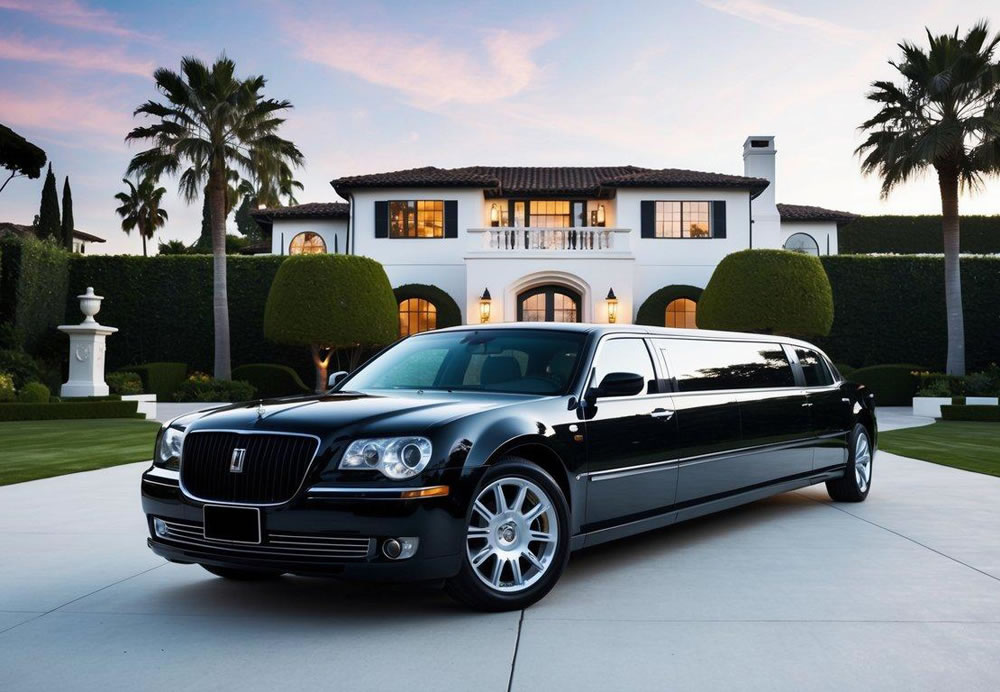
[183,391,537,437]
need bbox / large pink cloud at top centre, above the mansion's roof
[287,22,554,108]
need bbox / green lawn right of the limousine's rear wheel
[878,421,1000,476]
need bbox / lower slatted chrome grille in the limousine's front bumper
[156,519,375,560]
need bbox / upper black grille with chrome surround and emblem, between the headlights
[181,430,319,504]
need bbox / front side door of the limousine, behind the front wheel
[584,336,677,528]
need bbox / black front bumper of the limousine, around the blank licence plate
[142,468,465,581]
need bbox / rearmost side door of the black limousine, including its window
[789,346,851,470]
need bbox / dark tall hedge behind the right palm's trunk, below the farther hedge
[816,255,1000,371]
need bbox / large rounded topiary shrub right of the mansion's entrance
[697,250,833,338]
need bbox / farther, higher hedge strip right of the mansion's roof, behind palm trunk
[838,215,1000,254]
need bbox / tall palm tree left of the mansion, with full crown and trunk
[126,55,303,380]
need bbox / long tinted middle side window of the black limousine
[657,339,795,392]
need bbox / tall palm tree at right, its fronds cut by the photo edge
[856,21,1000,375]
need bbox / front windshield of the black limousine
[343,329,586,395]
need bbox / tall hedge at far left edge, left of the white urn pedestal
[0,236,70,351]
